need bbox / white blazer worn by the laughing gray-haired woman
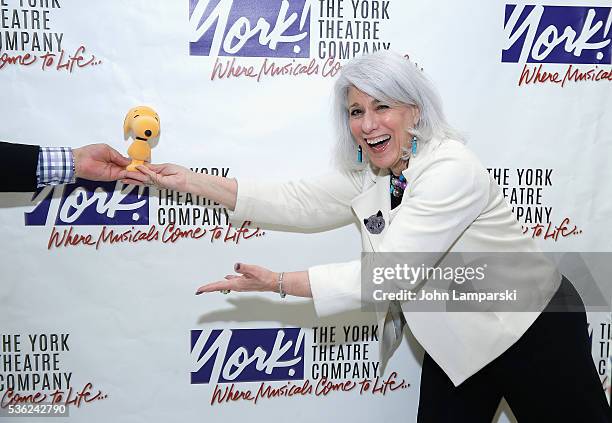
[231,140,561,385]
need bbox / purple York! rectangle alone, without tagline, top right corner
[502,4,612,64]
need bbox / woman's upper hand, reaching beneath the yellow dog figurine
[122,163,192,192]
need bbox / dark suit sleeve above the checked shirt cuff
[0,142,40,192]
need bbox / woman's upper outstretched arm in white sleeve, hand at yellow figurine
[123,163,363,232]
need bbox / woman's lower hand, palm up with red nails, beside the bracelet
[196,263,278,295]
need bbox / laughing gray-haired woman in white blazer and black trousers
[126,51,609,423]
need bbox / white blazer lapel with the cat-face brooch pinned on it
[351,172,391,251]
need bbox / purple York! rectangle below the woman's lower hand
[191,328,304,384]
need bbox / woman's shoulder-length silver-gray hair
[333,50,462,170]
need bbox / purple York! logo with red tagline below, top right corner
[502,4,612,86]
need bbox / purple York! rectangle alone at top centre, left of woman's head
[189,0,310,57]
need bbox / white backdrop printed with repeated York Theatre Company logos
[0,0,612,422]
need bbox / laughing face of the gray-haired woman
[348,87,419,175]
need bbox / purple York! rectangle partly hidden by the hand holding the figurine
[25,179,149,226]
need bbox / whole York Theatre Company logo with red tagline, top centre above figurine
[189,0,391,81]
